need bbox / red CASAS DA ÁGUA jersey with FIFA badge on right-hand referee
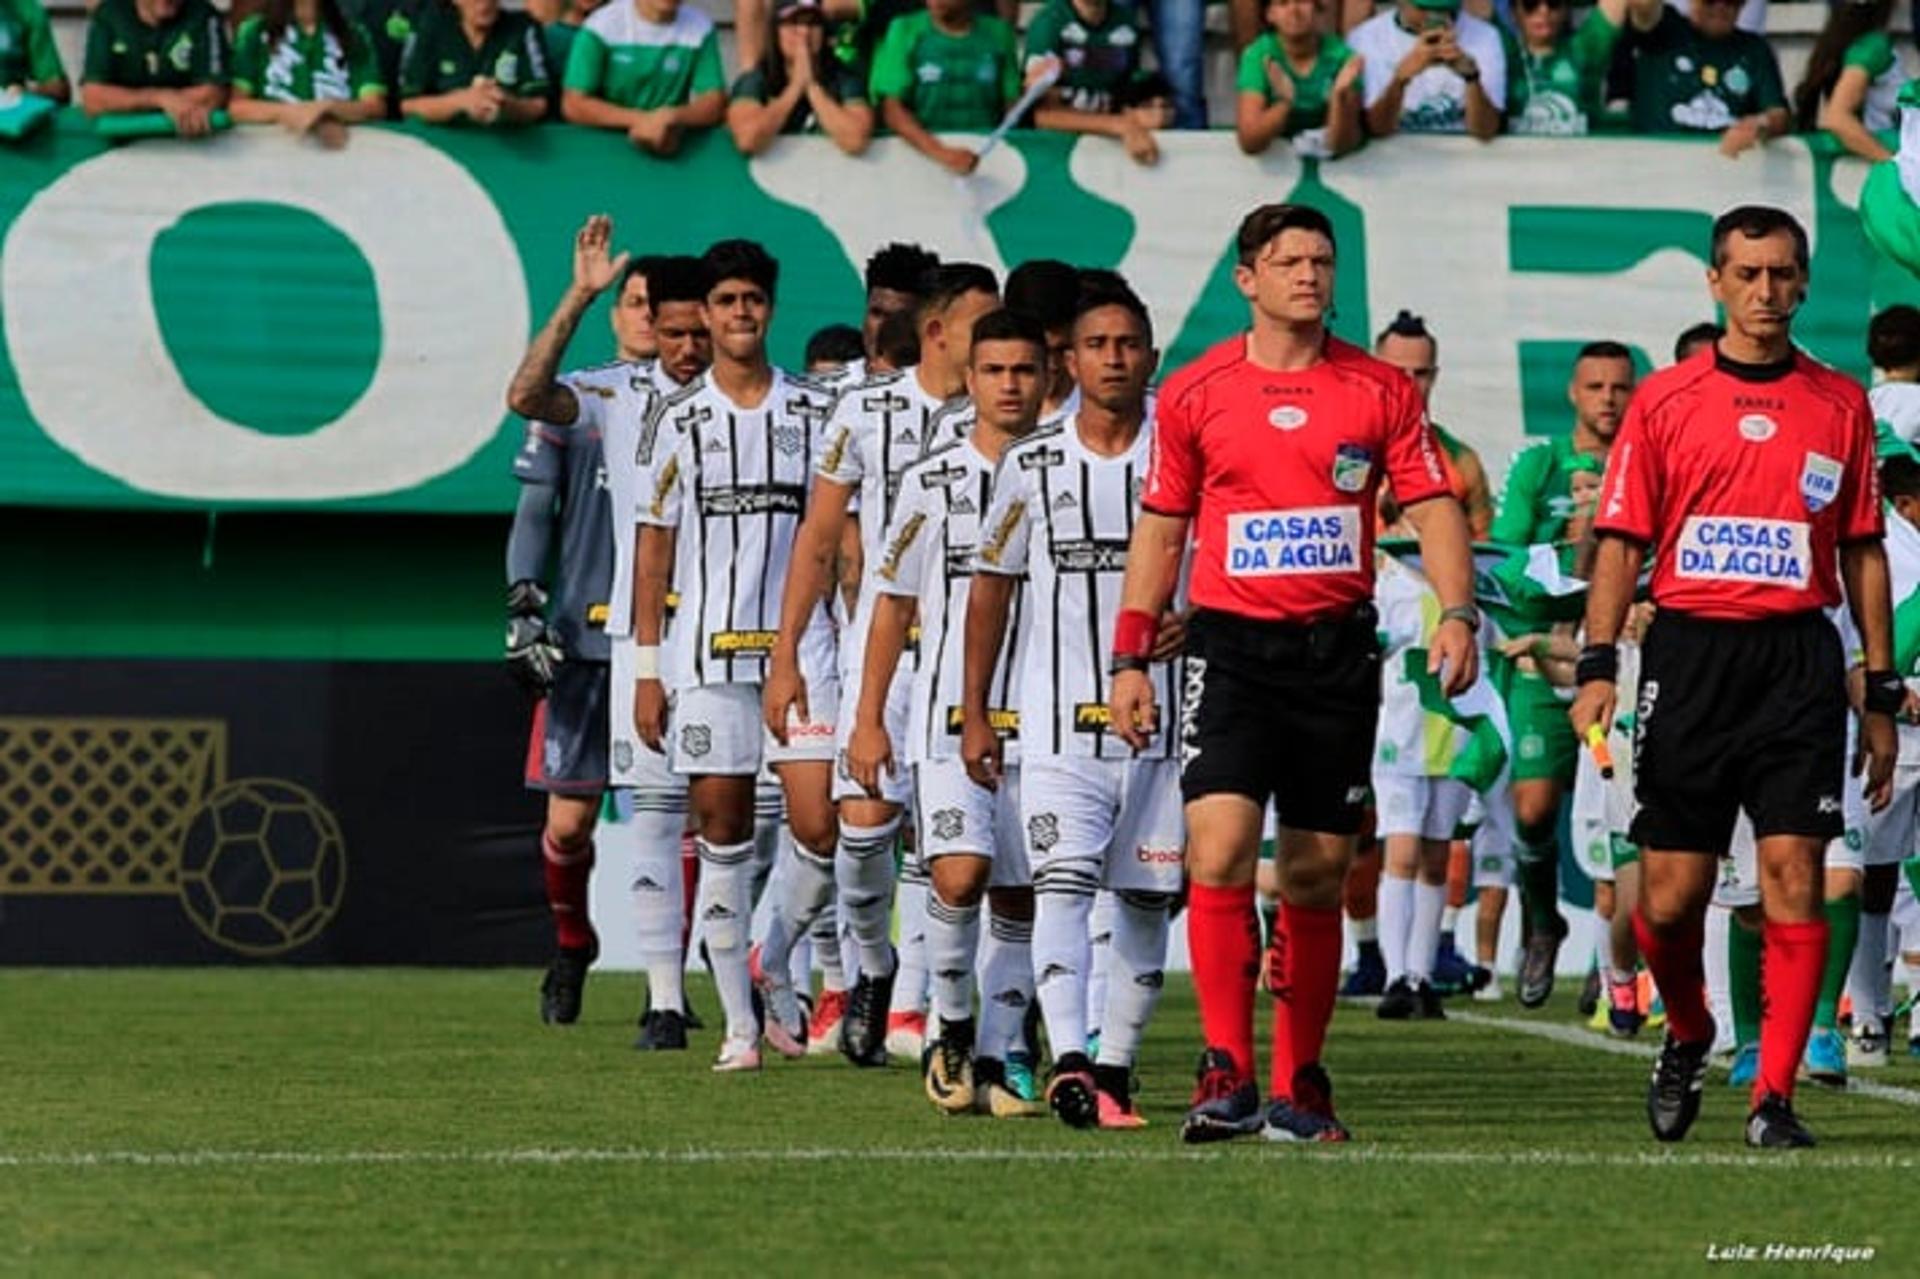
[1594,350,1884,620]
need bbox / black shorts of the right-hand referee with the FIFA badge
[1630,611,1847,857]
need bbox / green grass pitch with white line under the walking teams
[0,970,1920,1275]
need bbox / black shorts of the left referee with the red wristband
[1181,605,1380,835]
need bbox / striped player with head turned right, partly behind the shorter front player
[760,263,998,1066]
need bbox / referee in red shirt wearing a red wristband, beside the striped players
[1110,204,1478,1141]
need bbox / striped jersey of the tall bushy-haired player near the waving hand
[639,369,831,688]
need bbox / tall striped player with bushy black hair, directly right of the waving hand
[634,240,835,1072]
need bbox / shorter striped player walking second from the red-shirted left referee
[847,311,1046,1116]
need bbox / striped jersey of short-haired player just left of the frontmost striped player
[862,440,1027,764]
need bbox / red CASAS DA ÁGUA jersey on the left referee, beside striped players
[1140,334,1450,622]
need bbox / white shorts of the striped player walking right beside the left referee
[1020,755,1187,893]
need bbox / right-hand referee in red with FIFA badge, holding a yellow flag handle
[1572,205,1905,1146]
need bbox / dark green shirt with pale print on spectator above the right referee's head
[1632,10,1788,133]
